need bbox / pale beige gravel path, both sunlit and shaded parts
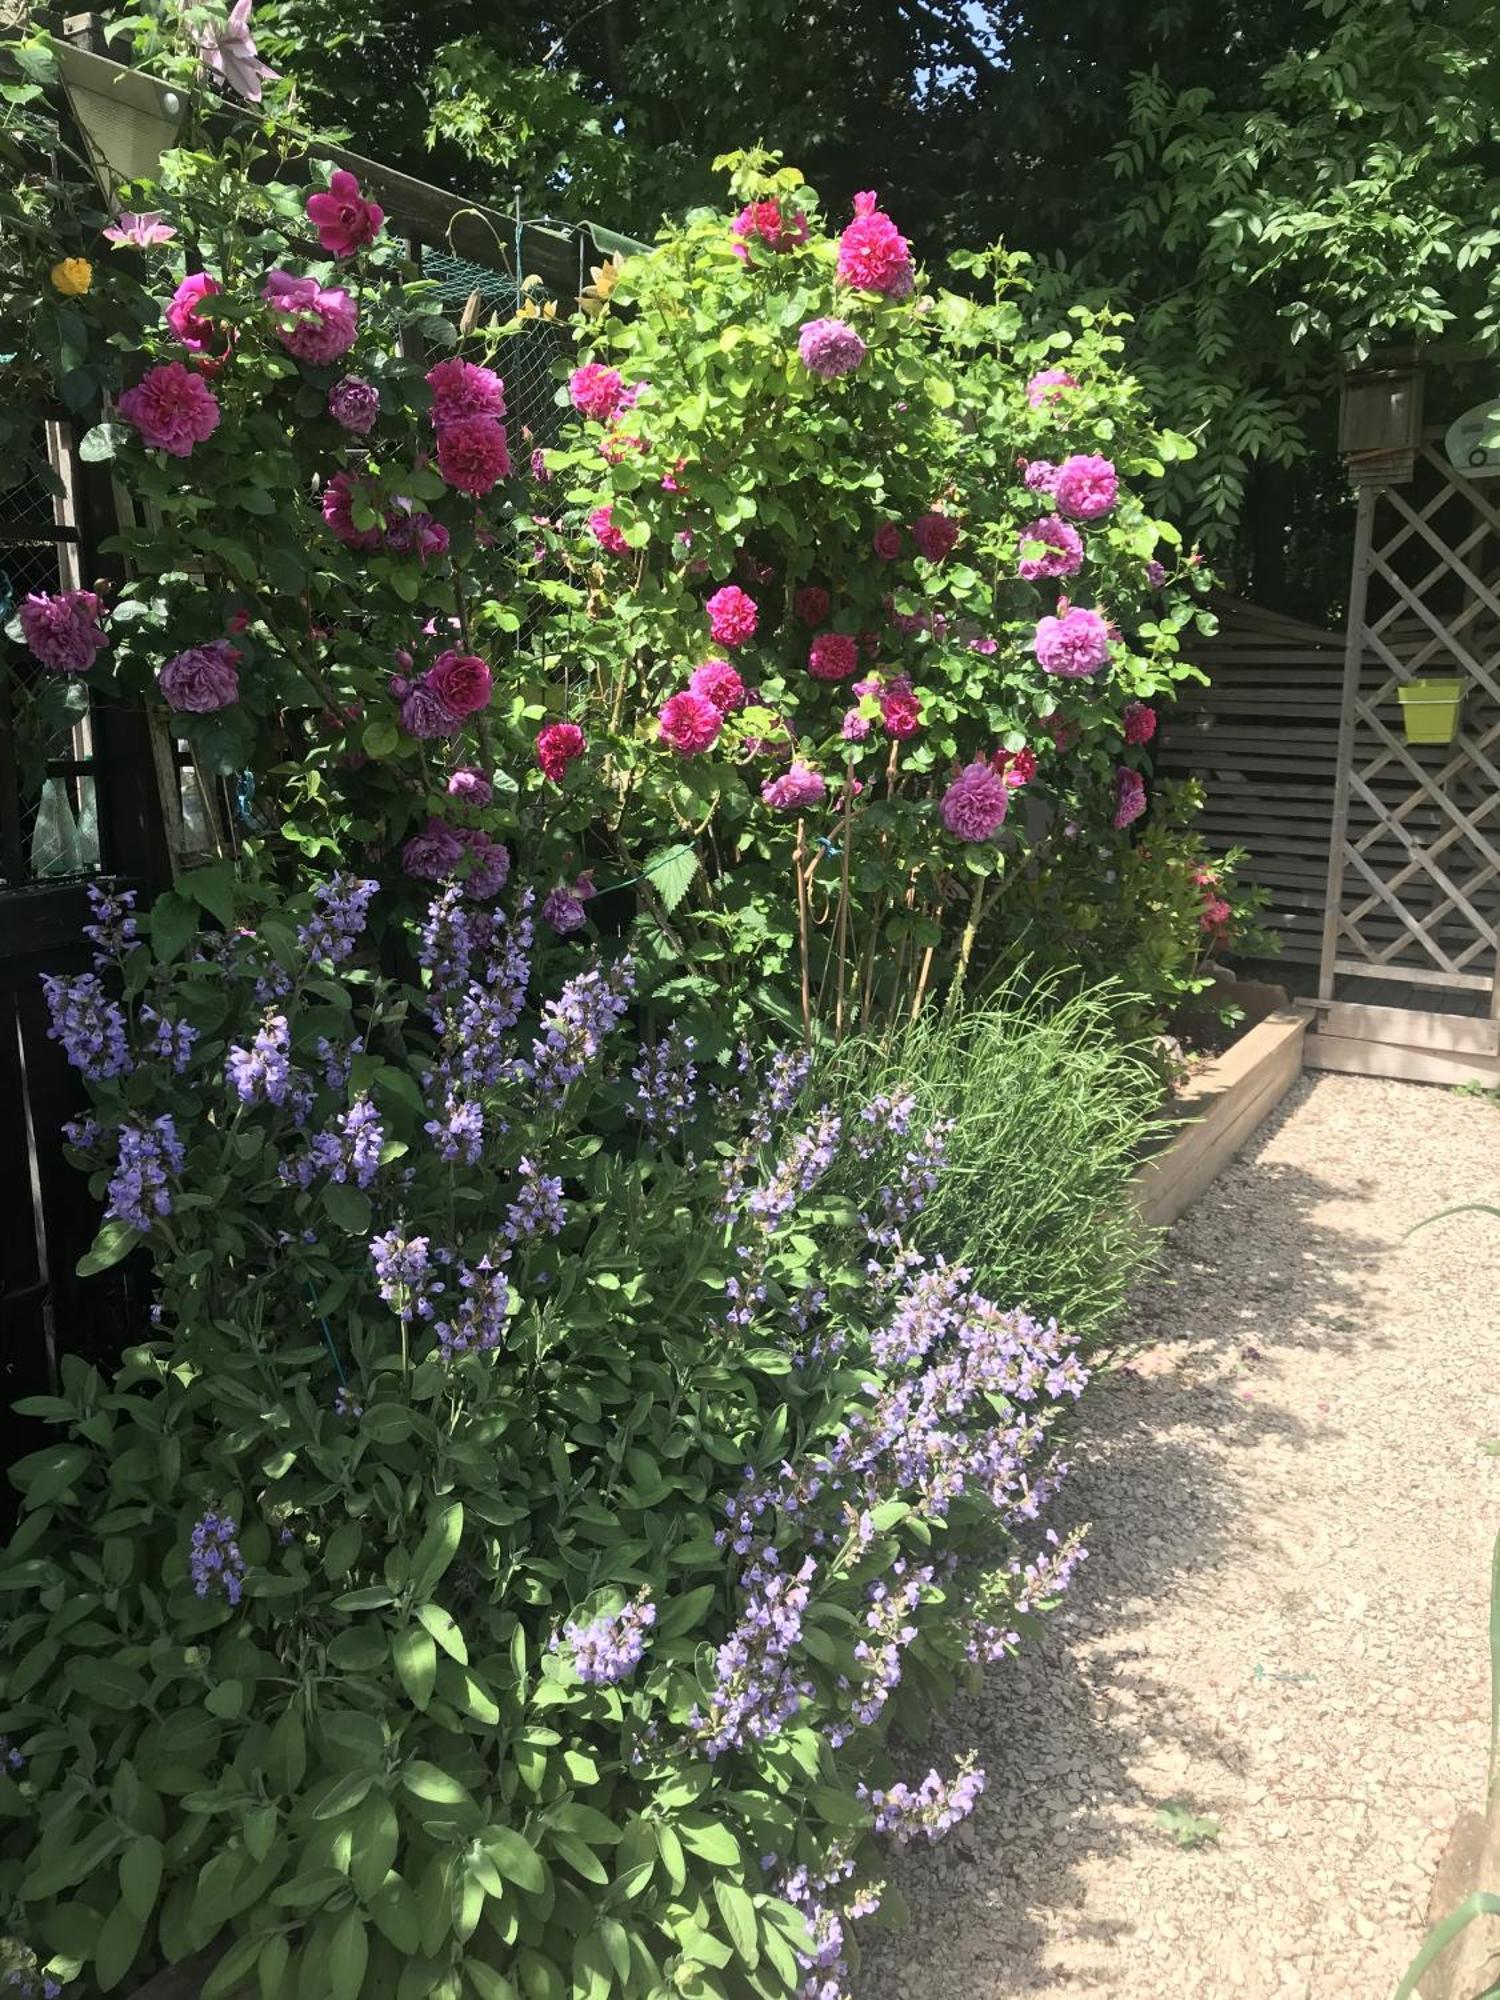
[854,1076,1500,2000]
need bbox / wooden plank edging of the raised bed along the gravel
[1130,1008,1308,1228]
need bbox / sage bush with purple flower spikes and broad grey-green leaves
[0,878,1084,2000]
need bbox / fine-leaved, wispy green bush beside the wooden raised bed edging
[846,970,1162,1344]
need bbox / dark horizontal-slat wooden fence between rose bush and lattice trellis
[1156,596,1344,966]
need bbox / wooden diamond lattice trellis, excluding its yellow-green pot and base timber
[1320,446,1500,1004]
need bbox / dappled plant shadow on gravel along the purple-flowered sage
[852,1086,1392,2000]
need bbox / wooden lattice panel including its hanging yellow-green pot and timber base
[1308,442,1500,1082]
